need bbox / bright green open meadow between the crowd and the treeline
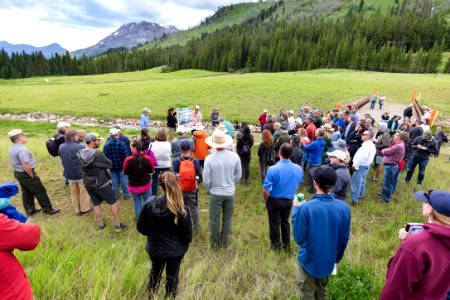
[0,68,450,121]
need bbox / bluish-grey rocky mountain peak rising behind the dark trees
[72,20,180,57]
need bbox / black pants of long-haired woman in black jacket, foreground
[148,255,184,298]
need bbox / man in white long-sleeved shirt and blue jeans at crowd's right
[351,130,377,205]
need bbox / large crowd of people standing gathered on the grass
[0,101,450,299]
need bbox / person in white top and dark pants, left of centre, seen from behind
[148,129,172,196]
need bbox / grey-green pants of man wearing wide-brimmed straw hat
[209,193,234,247]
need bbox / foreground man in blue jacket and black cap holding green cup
[292,166,350,300]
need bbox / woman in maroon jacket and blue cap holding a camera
[380,190,450,300]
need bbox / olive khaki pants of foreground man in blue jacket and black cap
[297,262,329,300]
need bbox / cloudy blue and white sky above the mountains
[0,0,254,51]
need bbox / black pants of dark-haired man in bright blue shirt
[266,198,292,249]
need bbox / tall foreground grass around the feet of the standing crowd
[0,119,450,299]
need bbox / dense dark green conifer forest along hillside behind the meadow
[0,11,450,79]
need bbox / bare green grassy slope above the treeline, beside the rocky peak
[142,1,274,49]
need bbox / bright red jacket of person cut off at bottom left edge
[0,214,41,300]
